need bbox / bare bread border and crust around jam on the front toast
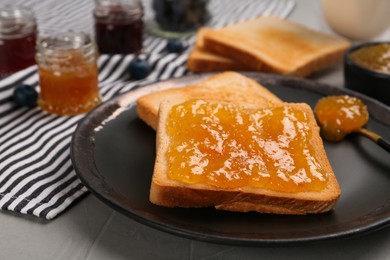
[150,101,340,215]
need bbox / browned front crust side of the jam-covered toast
[150,182,339,215]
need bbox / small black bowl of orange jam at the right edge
[344,42,390,105]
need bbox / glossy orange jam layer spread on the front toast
[166,100,328,192]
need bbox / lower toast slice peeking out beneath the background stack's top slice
[187,27,249,72]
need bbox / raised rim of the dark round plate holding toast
[70,72,390,246]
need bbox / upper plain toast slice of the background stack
[203,16,350,76]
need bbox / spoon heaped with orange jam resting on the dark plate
[314,95,390,152]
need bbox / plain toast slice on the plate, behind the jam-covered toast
[137,72,282,130]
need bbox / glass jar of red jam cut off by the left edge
[0,6,37,77]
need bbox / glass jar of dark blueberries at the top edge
[147,0,211,38]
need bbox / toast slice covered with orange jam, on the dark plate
[150,100,340,215]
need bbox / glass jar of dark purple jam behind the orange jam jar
[93,0,143,54]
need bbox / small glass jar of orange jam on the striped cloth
[36,32,101,115]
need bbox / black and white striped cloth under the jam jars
[0,0,295,219]
